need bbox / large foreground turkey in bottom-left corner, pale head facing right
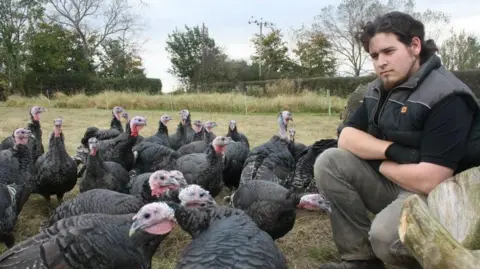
[0,208,173,269]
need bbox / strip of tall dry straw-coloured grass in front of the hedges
[5,91,346,113]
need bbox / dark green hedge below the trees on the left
[23,73,162,96]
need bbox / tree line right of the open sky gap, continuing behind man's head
[166,0,480,91]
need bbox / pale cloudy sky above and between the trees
[129,0,480,92]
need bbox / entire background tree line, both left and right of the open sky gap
[0,0,480,97]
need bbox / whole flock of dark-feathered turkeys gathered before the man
[0,106,337,269]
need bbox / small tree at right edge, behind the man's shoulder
[440,30,480,70]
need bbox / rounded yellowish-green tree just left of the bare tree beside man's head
[293,32,336,77]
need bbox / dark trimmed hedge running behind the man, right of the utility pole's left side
[210,69,480,98]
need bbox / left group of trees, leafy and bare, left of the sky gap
[0,0,150,97]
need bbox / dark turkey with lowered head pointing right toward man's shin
[226,180,331,240]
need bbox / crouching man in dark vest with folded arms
[314,12,478,269]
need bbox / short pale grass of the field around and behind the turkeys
[0,105,339,269]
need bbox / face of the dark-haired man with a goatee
[369,33,421,89]
